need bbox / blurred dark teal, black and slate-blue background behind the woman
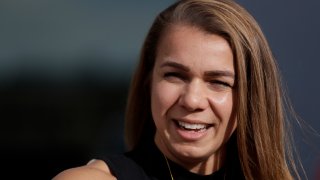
[0,0,320,180]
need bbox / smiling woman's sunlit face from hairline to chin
[151,25,237,172]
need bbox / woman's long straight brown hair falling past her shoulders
[125,0,300,180]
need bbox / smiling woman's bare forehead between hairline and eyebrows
[156,25,233,71]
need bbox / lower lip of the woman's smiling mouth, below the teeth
[175,123,211,141]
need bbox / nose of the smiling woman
[179,80,209,111]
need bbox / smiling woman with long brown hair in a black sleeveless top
[55,0,300,180]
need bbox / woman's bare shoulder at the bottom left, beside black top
[53,160,116,180]
